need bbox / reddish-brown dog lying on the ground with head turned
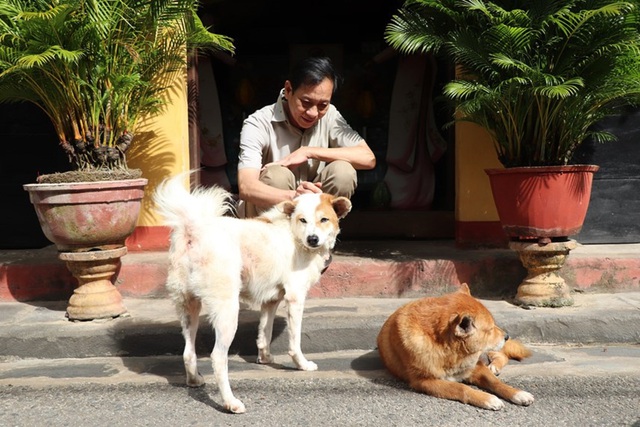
[378,284,533,410]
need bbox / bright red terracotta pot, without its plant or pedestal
[485,165,599,239]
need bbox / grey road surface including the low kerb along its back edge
[0,345,640,427]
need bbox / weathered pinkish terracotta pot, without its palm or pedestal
[23,178,147,252]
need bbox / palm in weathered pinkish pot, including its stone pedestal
[0,0,233,319]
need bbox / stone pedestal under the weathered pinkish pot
[58,246,127,320]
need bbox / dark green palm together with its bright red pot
[385,0,640,243]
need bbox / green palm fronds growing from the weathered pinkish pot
[0,0,233,169]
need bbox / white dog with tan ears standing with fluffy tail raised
[154,175,351,413]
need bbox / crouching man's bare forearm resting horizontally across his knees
[274,139,376,169]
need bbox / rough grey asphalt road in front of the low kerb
[0,376,640,427]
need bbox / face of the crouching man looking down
[284,79,333,129]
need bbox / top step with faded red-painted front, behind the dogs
[0,240,640,301]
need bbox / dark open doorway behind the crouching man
[198,0,455,239]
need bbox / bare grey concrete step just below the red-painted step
[0,292,640,362]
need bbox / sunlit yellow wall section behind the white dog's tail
[127,74,189,226]
